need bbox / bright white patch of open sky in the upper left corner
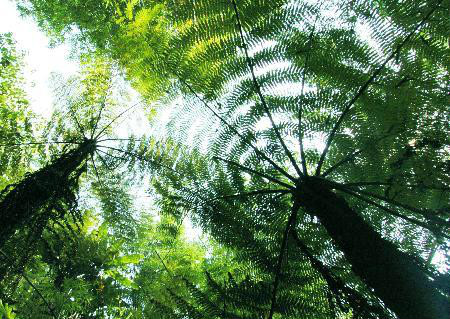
[0,0,78,118]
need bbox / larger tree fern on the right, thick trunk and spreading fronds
[13,0,450,318]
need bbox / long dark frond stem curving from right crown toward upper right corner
[316,0,442,176]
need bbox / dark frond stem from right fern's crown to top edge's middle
[231,0,304,176]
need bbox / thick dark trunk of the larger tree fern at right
[298,178,450,319]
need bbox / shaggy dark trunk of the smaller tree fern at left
[0,141,95,248]
